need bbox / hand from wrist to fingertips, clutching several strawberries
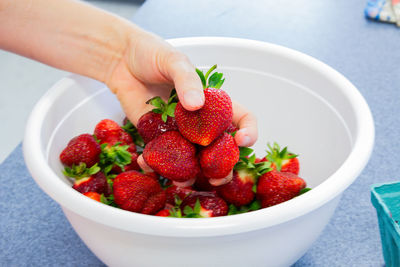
[106,29,257,186]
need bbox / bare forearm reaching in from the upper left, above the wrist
[0,0,137,82]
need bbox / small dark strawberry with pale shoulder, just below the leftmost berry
[72,172,110,195]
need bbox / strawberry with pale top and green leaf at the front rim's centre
[181,192,228,217]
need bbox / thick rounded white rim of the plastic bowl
[23,37,375,237]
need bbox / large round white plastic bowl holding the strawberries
[24,37,374,266]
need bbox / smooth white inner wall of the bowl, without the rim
[47,45,355,191]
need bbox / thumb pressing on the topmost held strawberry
[166,51,205,111]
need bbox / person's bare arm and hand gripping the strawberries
[0,0,257,186]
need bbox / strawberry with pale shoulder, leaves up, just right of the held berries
[216,147,271,207]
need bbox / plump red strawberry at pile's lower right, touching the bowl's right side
[257,171,306,208]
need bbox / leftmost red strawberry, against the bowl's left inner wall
[60,134,101,168]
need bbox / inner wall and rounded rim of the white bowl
[24,38,374,236]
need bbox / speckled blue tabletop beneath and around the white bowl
[0,0,400,267]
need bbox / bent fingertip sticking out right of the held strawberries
[232,101,258,147]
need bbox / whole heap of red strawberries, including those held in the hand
[60,66,309,218]
